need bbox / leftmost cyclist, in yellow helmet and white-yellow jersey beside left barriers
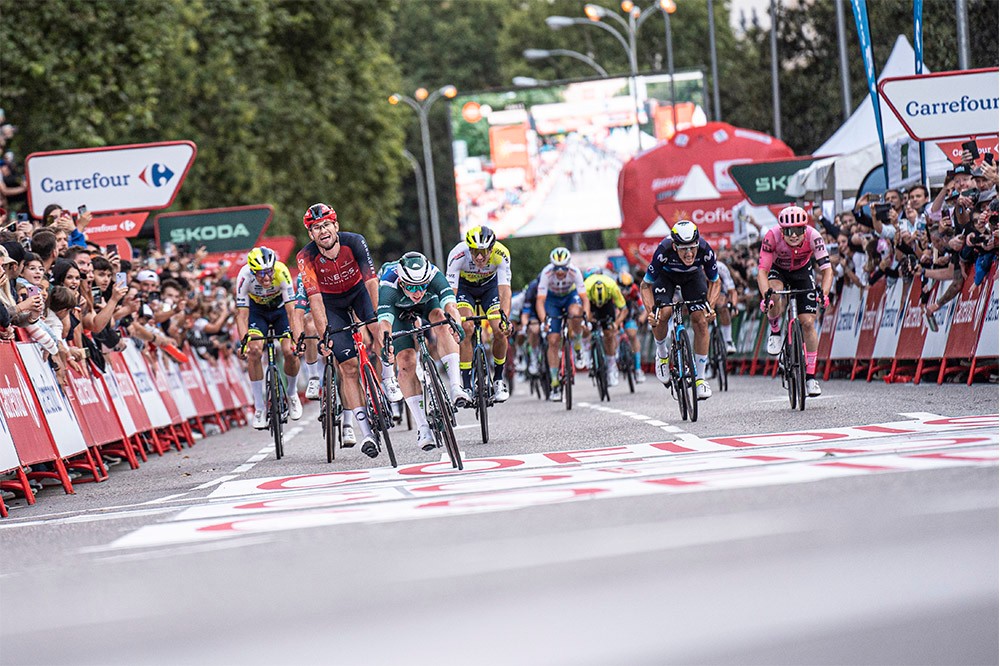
[236,246,302,430]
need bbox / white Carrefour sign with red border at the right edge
[879,67,1000,141]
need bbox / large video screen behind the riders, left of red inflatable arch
[451,71,707,238]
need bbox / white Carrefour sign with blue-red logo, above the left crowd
[24,141,198,218]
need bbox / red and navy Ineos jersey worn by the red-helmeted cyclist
[296,231,375,297]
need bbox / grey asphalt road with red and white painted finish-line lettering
[0,370,1000,664]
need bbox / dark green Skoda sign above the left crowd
[153,204,274,253]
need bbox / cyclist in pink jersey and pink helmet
[757,206,833,397]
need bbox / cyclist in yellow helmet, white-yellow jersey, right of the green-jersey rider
[448,227,510,406]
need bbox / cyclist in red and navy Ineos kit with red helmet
[297,203,381,458]
